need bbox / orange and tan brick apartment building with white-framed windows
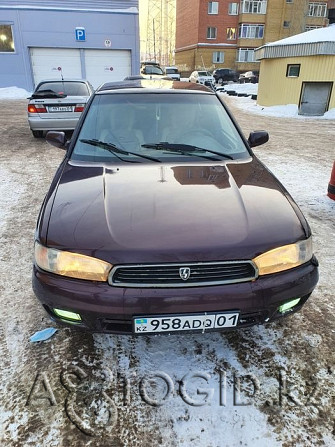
[175,0,333,75]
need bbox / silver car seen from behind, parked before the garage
[28,79,94,138]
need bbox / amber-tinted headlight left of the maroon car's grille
[35,242,113,281]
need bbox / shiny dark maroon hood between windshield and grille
[45,158,308,263]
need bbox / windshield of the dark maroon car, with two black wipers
[71,92,249,163]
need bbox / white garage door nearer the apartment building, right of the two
[84,50,131,88]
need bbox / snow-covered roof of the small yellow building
[255,25,335,59]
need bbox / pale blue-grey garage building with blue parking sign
[0,0,140,91]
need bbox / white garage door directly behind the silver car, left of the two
[30,48,82,85]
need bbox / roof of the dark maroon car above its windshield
[96,78,214,94]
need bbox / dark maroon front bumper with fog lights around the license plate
[33,259,318,334]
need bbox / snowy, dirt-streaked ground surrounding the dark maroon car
[0,85,335,447]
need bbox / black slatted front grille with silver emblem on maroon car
[109,261,257,288]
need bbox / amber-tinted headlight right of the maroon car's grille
[253,237,313,275]
